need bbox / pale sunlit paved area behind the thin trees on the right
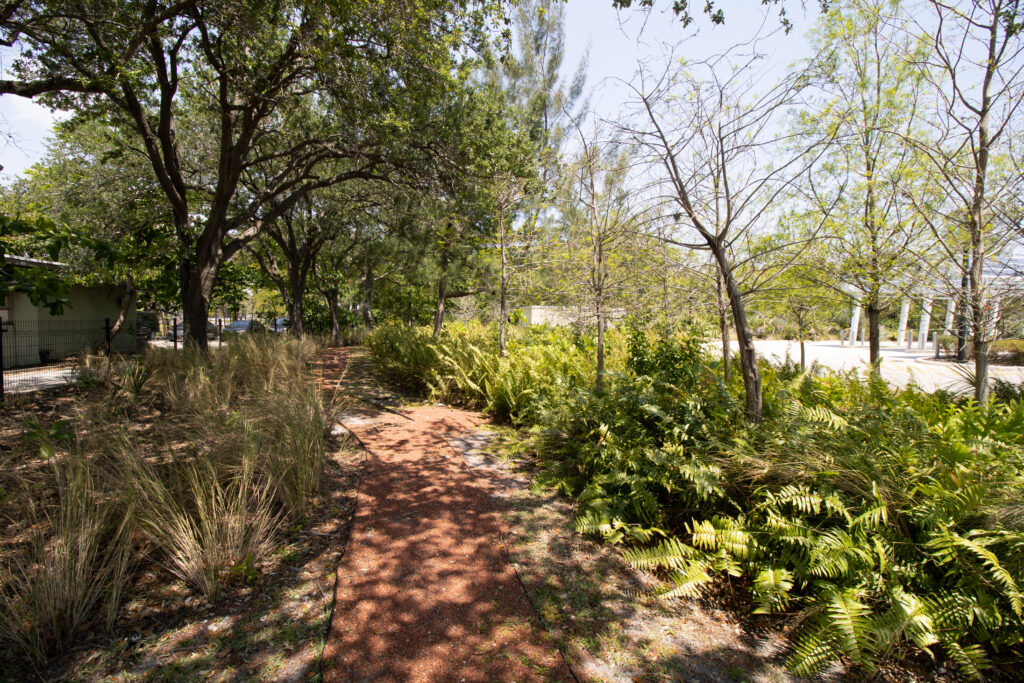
[733,339,1024,392]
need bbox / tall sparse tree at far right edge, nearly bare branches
[910,0,1024,402]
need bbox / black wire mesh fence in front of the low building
[0,318,139,397]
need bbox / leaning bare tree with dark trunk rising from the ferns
[623,53,823,422]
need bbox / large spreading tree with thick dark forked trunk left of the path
[0,0,503,348]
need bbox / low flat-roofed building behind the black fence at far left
[0,255,136,368]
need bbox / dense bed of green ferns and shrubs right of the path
[369,327,1024,678]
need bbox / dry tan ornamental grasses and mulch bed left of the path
[0,336,344,678]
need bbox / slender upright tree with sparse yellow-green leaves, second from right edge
[798,0,928,365]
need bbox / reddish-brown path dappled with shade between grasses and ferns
[324,349,573,682]
